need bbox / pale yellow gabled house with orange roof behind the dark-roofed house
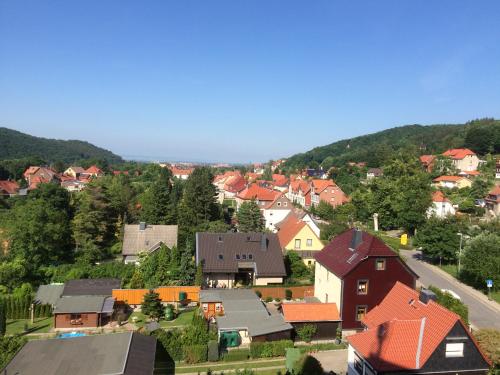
[278,214,324,266]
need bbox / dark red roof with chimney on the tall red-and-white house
[314,229,398,278]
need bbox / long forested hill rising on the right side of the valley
[285,119,500,170]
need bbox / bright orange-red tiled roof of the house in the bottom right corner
[348,282,488,371]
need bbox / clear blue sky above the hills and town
[0,0,500,162]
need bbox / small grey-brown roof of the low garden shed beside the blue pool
[54,296,114,314]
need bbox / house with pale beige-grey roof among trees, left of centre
[122,222,178,263]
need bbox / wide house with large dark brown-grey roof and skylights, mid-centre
[196,233,286,288]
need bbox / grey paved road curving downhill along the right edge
[401,250,500,330]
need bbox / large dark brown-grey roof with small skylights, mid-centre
[196,233,286,277]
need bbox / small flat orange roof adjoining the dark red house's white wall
[281,303,340,323]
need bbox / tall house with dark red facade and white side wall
[314,229,418,335]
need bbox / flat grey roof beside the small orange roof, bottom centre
[200,289,293,337]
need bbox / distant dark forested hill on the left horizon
[0,127,123,164]
